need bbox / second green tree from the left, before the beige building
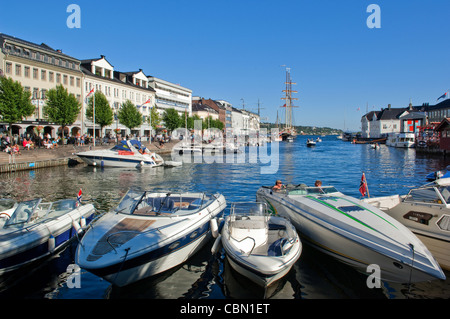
[43,85,81,139]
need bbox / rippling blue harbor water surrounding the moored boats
[0,136,450,300]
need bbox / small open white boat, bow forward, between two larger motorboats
[221,203,302,288]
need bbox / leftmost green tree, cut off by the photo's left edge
[0,76,35,137]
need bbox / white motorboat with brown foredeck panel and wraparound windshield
[75,189,226,287]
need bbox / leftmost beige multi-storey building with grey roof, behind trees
[0,33,83,137]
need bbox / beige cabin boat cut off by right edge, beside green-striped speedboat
[364,178,450,270]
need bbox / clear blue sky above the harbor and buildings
[0,0,450,130]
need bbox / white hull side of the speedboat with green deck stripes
[257,191,445,283]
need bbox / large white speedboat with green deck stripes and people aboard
[257,184,445,283]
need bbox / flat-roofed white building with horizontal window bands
[147,76,192,116]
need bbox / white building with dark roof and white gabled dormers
[81,55,156,137]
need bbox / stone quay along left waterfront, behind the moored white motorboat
[0,141,178,173]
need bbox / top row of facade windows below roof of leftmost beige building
[5,62,81,88]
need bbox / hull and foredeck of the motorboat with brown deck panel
[75,194,226,287]
